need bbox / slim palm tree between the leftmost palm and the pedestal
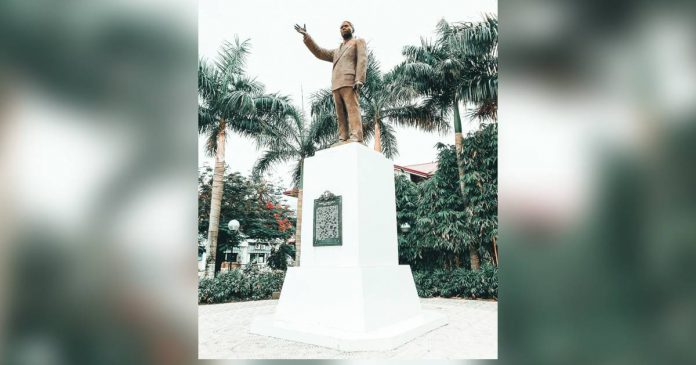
[252,104,336,266]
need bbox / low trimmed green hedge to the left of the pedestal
[198,267,285,304]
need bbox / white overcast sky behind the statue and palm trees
[198,0,498,199]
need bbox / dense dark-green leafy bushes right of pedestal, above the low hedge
[394,123,498,270]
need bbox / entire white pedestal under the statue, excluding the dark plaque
[251,143,447,351]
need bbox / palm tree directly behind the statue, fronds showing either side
[312,51,449,158]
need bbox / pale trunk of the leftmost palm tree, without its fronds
[206,119,227,278]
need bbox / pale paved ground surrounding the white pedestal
[198,298,498,359]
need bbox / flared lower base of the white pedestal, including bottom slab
[251,265,447,351]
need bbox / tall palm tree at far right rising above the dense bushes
[399,15,498,270]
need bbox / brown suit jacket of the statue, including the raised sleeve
[304,34,367,90]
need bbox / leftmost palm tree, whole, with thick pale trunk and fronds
[198,37,289,277]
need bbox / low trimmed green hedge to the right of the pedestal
[413,265,498,299]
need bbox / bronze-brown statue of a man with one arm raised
[295,21,367,146]
